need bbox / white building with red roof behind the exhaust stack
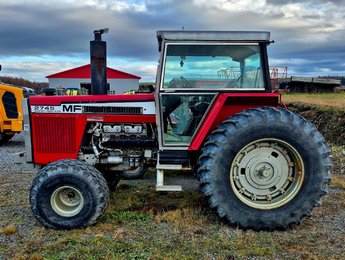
[46,64,141,94]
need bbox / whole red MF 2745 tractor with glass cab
[18,31,331,230]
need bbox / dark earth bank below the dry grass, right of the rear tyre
[287,103,345,146]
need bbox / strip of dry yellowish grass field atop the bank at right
[282,93,345,110]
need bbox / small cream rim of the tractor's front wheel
[50,186,84,217]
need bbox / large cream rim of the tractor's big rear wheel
[230,138,305,209]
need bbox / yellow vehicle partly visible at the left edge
[0,83,24,144]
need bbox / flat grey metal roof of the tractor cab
[157,30,270,51]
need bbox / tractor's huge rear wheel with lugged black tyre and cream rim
[198,108,331,230]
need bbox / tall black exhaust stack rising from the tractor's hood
[90,28,109,95]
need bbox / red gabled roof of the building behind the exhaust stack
[46,64,141,79]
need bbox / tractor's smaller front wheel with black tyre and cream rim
[30,160,109,229]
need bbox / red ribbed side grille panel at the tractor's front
[33,116,76,153]
